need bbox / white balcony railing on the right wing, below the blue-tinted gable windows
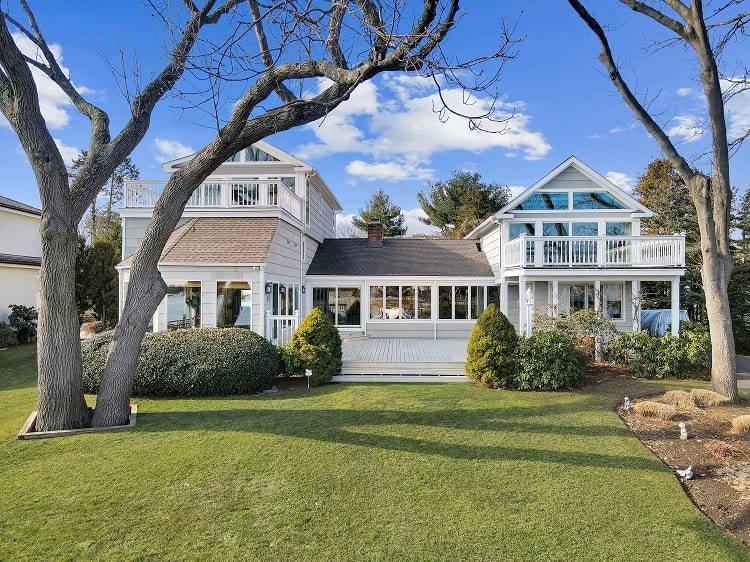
[503,235,685,268]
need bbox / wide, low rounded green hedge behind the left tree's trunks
[81,328,278,396]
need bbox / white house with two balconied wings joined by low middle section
[118,142,684,343]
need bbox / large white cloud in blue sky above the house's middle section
[296,76,551,181]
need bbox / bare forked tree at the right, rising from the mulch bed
[568,0,750,401]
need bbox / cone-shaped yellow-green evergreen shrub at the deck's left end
[285,308,341,386]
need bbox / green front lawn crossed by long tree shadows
[0,346,750,561]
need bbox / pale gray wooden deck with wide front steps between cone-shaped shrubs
[333,337,471,382]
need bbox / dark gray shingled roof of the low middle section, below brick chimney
[307,238,493,277]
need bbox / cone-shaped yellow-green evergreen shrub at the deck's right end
[466,304,518,388]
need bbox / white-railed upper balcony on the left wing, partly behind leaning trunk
[124,179,304,220]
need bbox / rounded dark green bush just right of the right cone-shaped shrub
[513,330,584,390]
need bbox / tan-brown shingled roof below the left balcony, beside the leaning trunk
[119,217,279,266]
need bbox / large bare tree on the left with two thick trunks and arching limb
[0,0,508,430]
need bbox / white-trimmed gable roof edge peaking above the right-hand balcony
[466,156,654,238]
